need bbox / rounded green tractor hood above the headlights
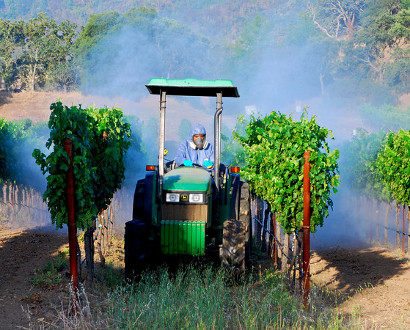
[163,167,211,191]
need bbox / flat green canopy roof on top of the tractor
[145,78,239,97]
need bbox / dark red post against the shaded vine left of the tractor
[64,139,78,309]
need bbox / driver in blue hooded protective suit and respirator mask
[174,124,214,171]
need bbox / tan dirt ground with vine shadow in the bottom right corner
[311,247,410,329]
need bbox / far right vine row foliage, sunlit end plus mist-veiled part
[341,129,410,205]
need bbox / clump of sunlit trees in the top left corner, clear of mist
[0,14,77,91]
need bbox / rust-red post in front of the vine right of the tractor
[303,151,310,307]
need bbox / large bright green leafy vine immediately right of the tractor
[236,111,339,233]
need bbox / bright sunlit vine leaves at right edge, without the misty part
[376,130,410,205]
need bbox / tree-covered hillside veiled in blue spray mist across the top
[0,0,410,113]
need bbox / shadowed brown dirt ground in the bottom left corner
[0,227,68,329]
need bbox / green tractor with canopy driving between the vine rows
[125,79,251,278]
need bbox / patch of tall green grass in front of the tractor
[107,267,300,329]
